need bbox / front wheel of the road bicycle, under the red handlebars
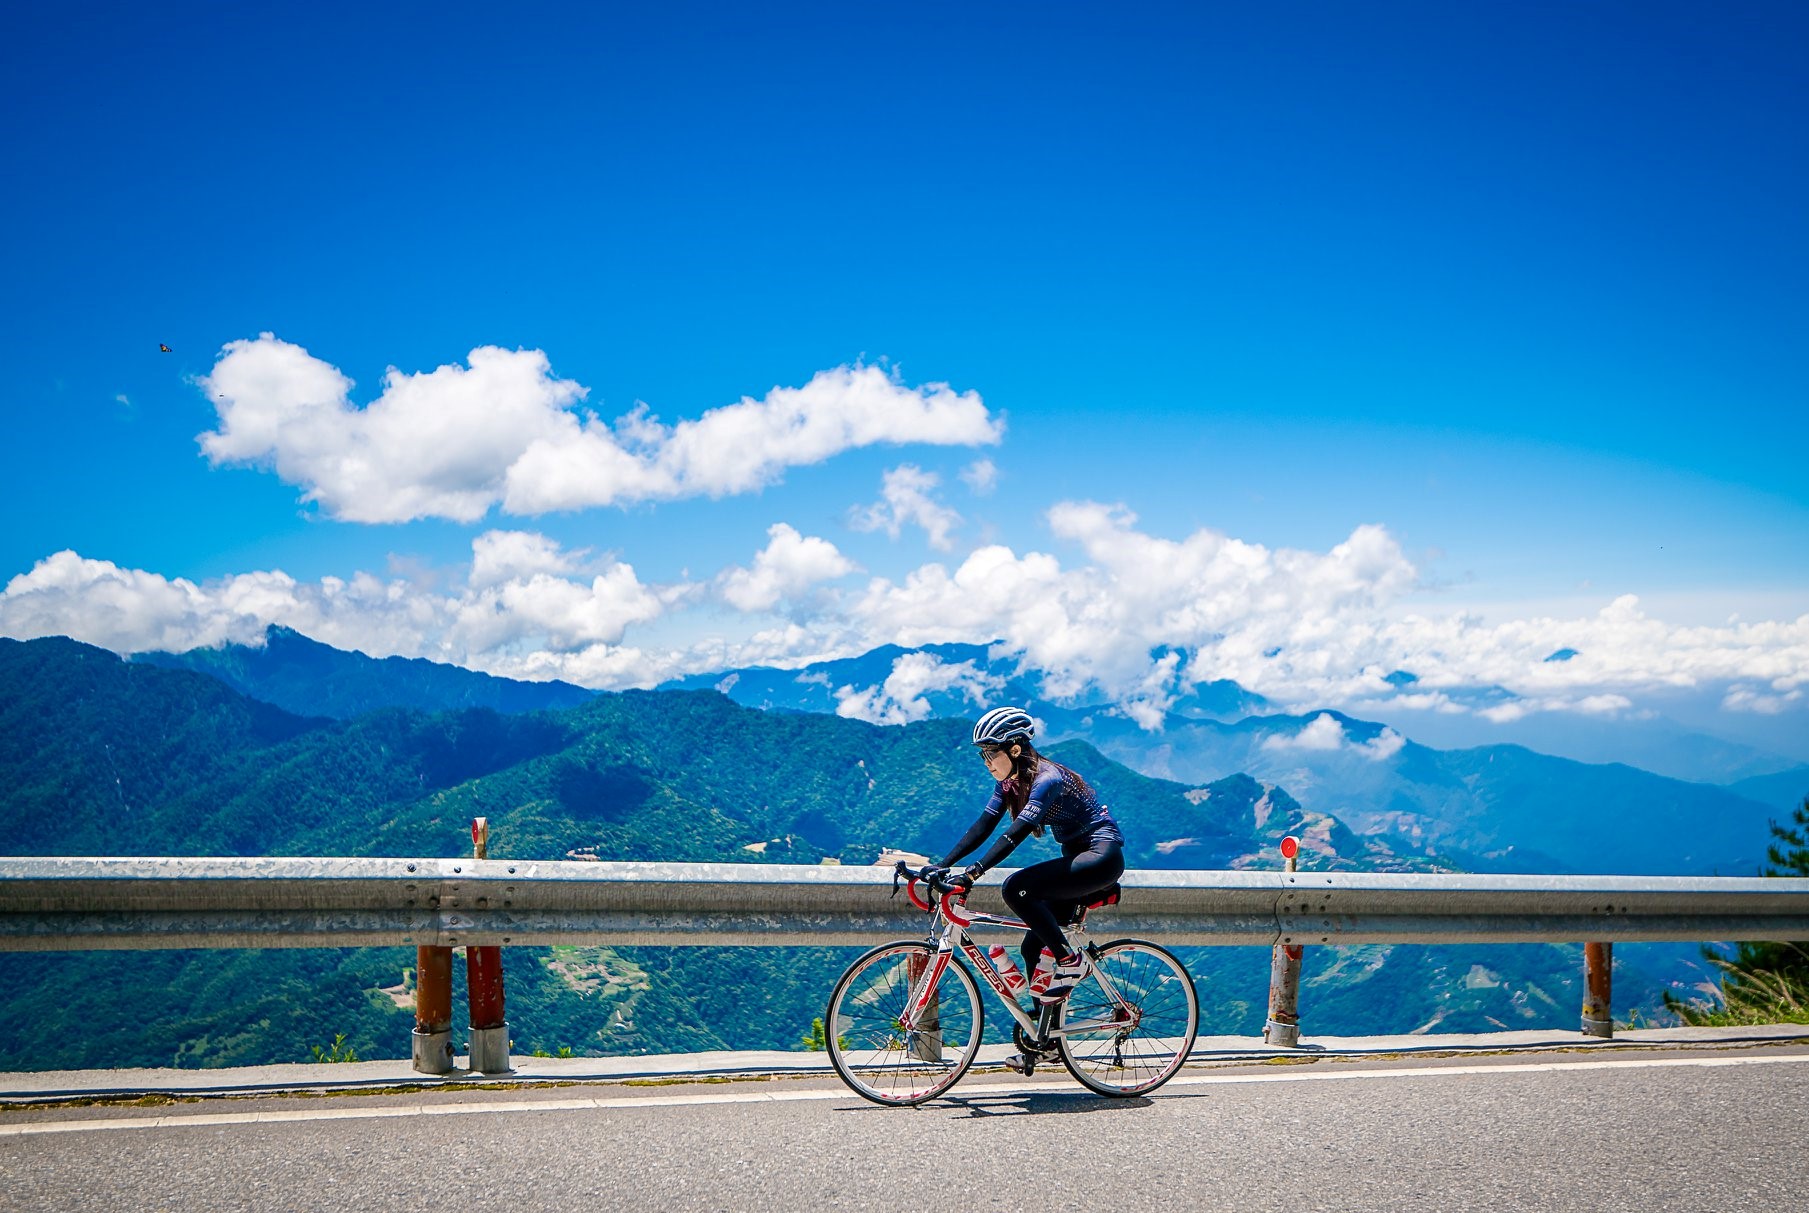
[823,940,982,1106]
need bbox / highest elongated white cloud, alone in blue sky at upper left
[199,333,1004,522]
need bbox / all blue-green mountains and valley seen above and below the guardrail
[0,633,1767,1068]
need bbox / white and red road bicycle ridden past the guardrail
[823,862,1199,1106]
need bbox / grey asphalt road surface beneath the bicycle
[0,1045,1809,1213]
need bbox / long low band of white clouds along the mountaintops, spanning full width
[0,503,1809,730]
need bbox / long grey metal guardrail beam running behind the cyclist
[0,859,1809,951]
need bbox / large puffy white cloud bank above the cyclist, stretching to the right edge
[818,503,1809,727]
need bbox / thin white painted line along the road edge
[0,1054,1809,1137]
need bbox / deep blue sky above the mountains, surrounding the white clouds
[0,4,1809,741]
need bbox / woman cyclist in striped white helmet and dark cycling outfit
[926,707,1125,1001]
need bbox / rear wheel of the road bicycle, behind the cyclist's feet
[1058,940,1199,1097]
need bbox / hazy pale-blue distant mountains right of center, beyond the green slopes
[666,645,1809,875]
